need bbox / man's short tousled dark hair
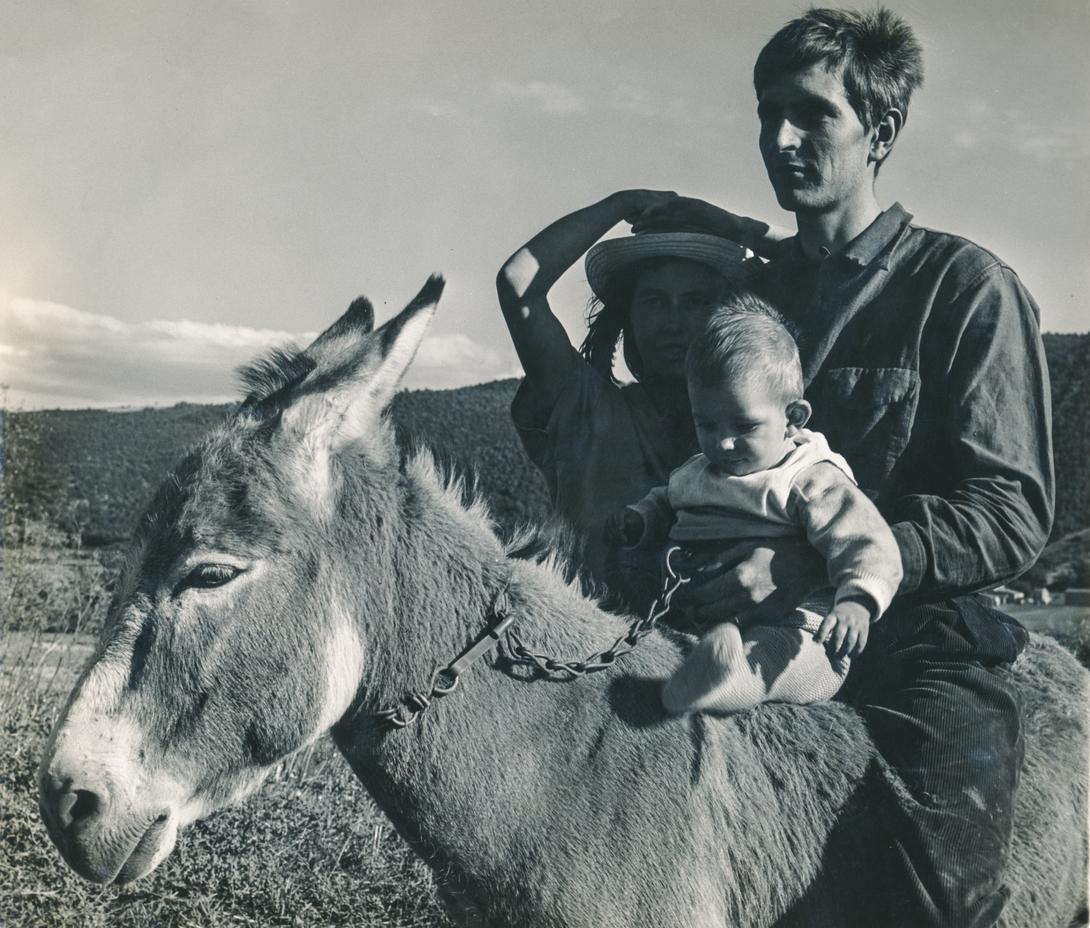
[753,7,923,129]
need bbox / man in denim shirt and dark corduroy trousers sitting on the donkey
[637,9,1053,928]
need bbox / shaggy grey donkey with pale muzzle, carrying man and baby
[39,278,1090,928]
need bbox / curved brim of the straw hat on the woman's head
[586,232,748,300]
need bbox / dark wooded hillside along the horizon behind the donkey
[2,334,1090,558]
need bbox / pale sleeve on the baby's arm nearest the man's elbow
[788,461,901,618]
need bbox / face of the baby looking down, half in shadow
[689,376,794,477]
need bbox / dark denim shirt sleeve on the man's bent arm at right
[886,264,1054,599]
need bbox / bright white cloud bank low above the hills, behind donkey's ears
[0,298,510,408]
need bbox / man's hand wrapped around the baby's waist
[678,538,828,628]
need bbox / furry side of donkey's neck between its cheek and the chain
[347,458,628,724]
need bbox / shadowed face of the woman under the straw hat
[626,260,723,383]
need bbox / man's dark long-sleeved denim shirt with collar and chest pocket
[752,204,1053,601]
